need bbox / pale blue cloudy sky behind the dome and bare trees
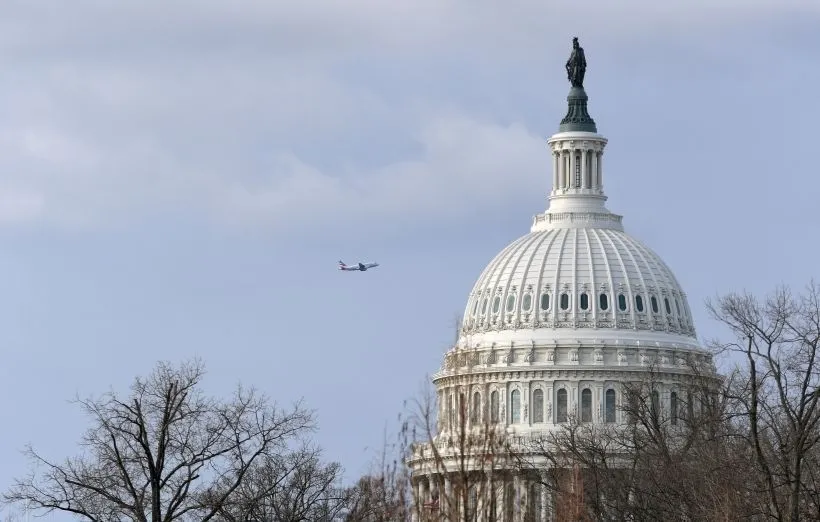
[0,0,820,520]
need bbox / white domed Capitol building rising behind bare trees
[409,38,714,521]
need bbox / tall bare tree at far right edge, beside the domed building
[708,281,820,521]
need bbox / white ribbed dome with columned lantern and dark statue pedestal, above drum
[444,87,707,362]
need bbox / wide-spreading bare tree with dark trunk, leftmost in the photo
[3,361,314,522]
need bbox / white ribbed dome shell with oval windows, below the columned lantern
[462,226,697,347]
